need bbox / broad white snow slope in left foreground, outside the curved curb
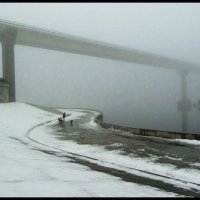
[0,103,176,197]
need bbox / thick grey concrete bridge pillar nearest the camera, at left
[1,28,17,102]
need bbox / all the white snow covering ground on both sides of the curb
[0,103,200,197]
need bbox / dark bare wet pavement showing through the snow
[29,107,200,197]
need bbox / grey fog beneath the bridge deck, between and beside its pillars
[15,45,200,132]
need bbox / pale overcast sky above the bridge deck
[0,3,200,63]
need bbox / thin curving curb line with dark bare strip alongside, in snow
[26,119,200,196]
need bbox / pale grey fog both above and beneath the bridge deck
[0,3,200,133]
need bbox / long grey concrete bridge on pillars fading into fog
[0,20,200,132]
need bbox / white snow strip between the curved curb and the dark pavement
[32,109,200,195]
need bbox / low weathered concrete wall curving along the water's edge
[95,114,200,140]
